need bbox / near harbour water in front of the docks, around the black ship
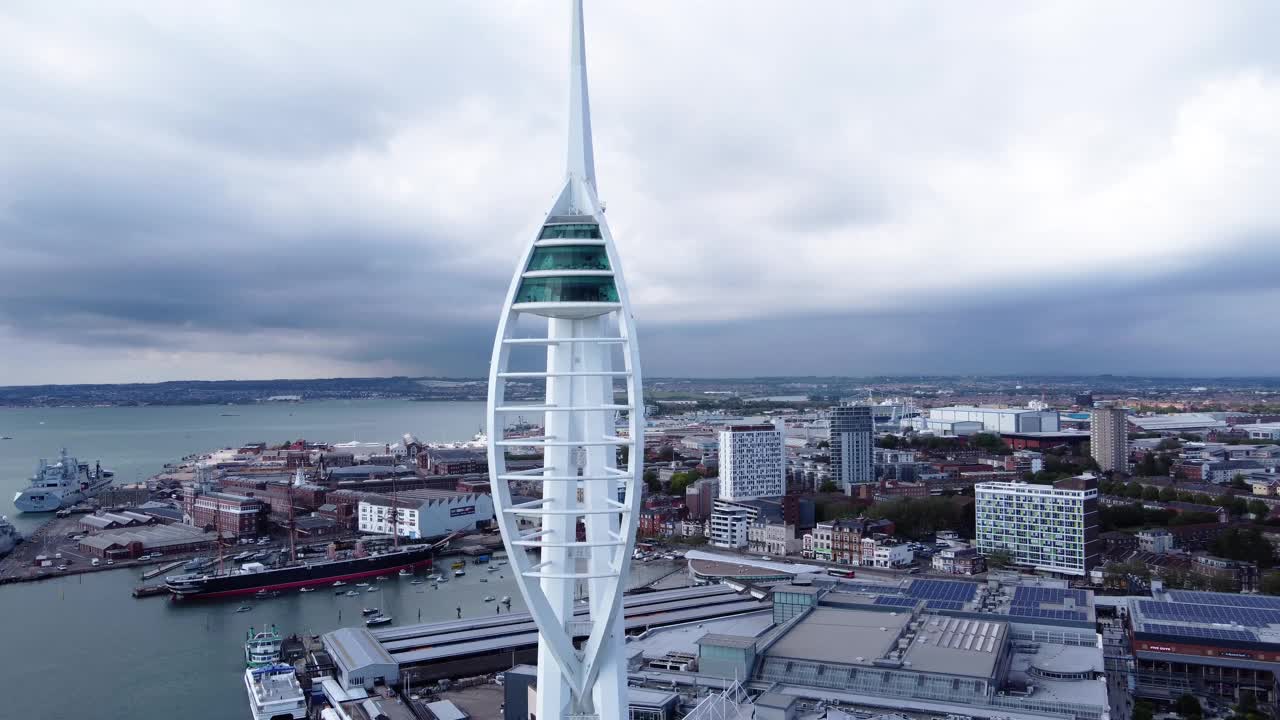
[0,540,672,720]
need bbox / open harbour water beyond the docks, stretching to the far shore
[0,400,484,533]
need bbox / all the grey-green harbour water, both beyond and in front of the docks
[0,400,671,720]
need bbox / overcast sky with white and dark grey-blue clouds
[0,0,1280,384]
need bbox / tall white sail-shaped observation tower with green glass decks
[488,0,644,720]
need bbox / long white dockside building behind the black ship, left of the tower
[356,489,494,539]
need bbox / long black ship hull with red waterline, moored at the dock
[165,547,433,600]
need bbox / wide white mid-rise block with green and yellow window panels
[974,475,1102,577]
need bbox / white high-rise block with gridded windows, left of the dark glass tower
[719,425,787,500]
